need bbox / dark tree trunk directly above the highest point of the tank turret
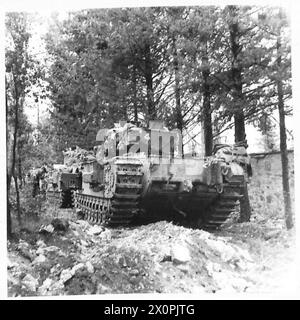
[145,44,157,120]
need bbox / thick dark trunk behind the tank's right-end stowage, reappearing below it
[229,6,251,222]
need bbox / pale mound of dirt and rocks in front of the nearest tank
[8,220,268,296]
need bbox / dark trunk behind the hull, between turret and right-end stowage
[202,48,213,156]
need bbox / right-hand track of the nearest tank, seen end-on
[202,184,243,230]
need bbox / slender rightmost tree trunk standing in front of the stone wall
[277,37,294,230]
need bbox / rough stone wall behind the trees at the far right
[249,150,295,217]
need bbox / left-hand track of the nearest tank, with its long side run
[74,159,143,226]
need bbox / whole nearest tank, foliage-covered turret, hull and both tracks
[74,121,251,229]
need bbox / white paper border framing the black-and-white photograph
[0,0,300,305]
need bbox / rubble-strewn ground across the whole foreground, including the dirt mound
[7,200,300,297]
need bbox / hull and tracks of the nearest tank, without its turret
[75,156,244,229]
